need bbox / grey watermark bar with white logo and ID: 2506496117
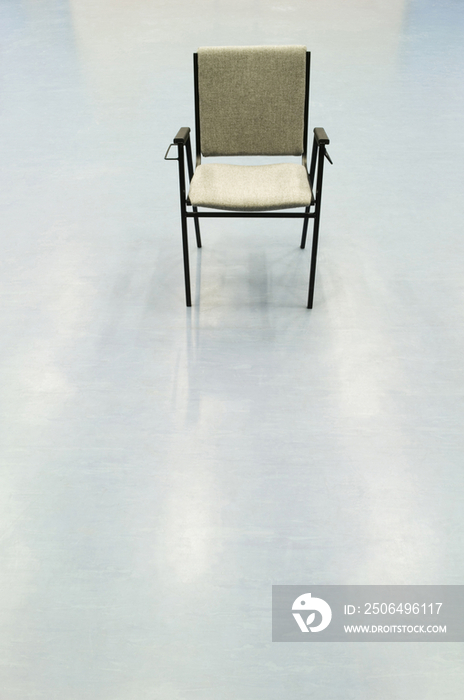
[272,585,464,643]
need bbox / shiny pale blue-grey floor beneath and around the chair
[0,0,464,700]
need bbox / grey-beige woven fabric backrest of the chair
[198,46,306,156]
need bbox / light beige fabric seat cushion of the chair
[189,163,312,211]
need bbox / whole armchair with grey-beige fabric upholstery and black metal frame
[165,46,332,309]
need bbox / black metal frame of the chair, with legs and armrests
[164,51,332,309]
